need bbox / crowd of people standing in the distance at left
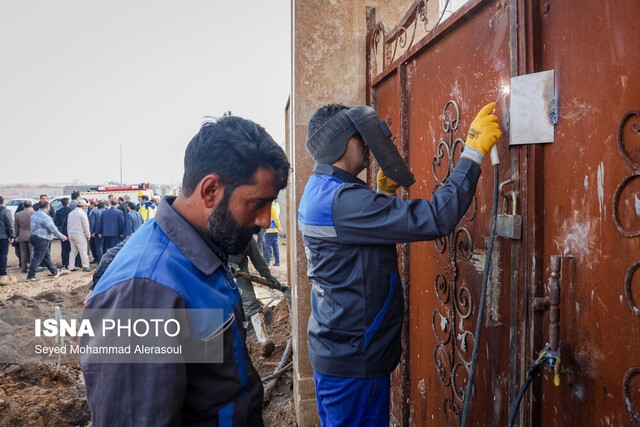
[0,191,160,284]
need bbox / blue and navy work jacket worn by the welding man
[298,158,480,378]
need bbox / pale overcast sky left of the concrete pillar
[0,0,291,184]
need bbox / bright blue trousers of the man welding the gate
[313,372,391,427]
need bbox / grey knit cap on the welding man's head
[304,110,358,165]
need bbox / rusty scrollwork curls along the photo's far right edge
[612,110,640,421]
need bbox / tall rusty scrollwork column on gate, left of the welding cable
[431,101,477,425]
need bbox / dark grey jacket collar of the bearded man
[155,196,226,275]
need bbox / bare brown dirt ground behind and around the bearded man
[0,240,297,427]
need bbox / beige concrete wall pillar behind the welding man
[292,0,412,426]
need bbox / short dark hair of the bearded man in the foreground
[182,114,289,197]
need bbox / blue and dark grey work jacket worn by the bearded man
[82,197,263,426]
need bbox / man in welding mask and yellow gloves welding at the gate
[298,103,501,426]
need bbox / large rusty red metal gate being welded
[368,0,640,425]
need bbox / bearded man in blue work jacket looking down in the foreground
[82,115,289,426]
